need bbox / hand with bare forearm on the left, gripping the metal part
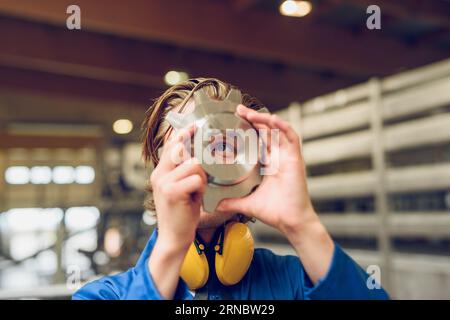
[148,127,207,299]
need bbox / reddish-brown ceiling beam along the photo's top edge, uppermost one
[0,0,445,77]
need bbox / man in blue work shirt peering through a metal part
[73,79,388,299]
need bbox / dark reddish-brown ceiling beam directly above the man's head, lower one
[0,18,357,109]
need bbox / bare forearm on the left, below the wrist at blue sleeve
[148,239,188,300]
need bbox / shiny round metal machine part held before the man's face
[166,89,268,213]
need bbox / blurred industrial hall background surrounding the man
[0,0,450,299]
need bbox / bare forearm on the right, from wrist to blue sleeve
[285,212,334,284]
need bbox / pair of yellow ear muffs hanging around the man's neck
[180,222,254,290]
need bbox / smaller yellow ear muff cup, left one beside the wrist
[180,243,209,290]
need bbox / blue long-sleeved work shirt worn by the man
[72,230,388,300]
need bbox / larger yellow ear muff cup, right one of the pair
[215,222,254,286]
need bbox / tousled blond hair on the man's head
[142,78,264,211]
